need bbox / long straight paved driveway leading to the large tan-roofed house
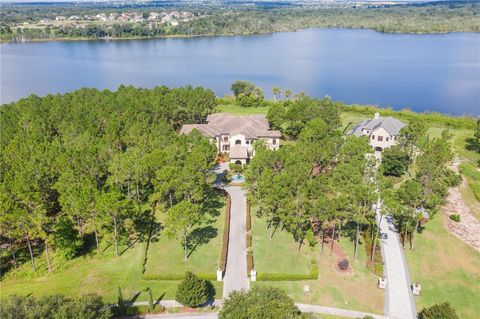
[215,163,250,298]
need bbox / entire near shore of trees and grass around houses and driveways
[0,82,480,318]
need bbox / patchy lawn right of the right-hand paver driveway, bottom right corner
[406,214,480,319]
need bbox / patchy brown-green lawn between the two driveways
[252,214,384,318]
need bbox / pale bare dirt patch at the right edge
[441,179,480,251]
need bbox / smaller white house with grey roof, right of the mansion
[352,113,406,151]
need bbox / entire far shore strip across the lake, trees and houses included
[0,1,480,42]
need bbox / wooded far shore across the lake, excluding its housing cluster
[0,1,480,41]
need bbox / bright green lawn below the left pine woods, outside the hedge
[1,244,222,302]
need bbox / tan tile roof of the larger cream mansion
[180,113,281,139]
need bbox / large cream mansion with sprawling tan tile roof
[180,113,281,164]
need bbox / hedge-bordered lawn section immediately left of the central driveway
[145,201,225,275]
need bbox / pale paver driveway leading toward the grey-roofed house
[376,205,417,319]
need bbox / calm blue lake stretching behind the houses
[0,29,480,115]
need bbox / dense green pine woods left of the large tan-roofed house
[0,86,216,274]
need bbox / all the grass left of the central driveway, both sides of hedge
[0,200,224,302]
